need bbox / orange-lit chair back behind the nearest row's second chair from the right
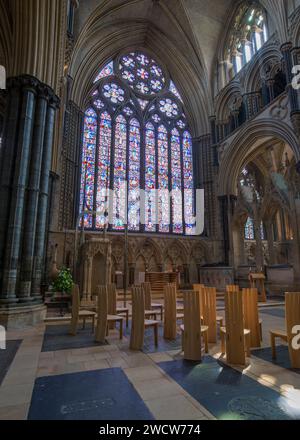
[243,289,261,348]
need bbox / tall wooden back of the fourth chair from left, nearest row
[182,290,201,361]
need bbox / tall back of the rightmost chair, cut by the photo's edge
[285,292,300,368]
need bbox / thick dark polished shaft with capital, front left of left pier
[0,76,38,304]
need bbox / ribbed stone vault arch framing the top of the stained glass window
[69,1,211,136]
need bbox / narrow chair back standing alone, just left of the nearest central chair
[164,284,177,340]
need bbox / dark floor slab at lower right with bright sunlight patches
[159,356,300,420]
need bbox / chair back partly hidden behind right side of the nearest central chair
[200,287,217,344]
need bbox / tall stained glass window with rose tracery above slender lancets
[79,51,195,235]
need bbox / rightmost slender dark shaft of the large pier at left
[31,96,58,299]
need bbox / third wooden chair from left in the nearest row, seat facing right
[130,287,159,350]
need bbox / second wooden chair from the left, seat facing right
[95,286,124,343]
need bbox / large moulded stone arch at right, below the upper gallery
[218,119,300,195]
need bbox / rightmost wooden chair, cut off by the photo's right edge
[270,292,300,368]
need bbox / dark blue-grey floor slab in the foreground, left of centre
[28,368,153,420]
